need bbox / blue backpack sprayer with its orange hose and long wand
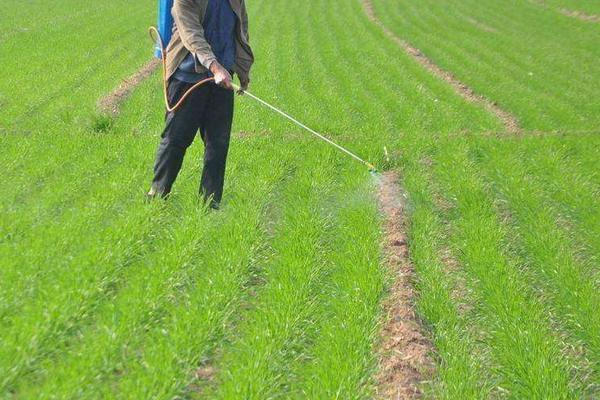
[149,0,377,173]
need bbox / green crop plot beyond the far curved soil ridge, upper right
[373,0,600,132]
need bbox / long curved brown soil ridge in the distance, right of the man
[362,0,521,133]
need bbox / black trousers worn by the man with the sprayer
[152,78,234,203]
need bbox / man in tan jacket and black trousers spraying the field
[148,0,254,209]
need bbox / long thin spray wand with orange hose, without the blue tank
[149,26,377,174]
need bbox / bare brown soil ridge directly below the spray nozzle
[376,172,434,399]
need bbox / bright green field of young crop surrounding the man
[0,0,600,399]
